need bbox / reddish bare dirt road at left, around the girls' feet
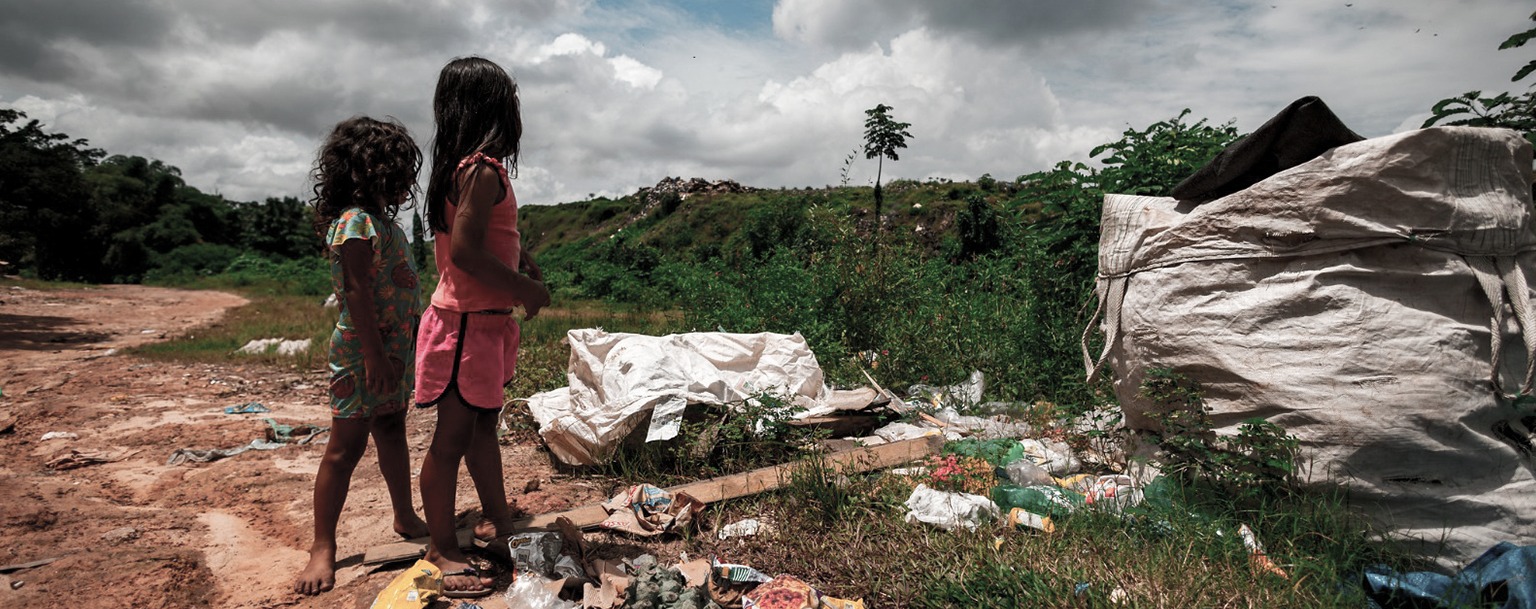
[0,286,602,609]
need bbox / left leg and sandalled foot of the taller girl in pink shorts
[421,395,492,591]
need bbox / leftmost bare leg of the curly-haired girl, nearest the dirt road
[293,418,369,594]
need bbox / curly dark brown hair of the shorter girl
[309,117,421,234]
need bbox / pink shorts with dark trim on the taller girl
[416,306,522,411]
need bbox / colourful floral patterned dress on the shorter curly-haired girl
[326,208,421,418]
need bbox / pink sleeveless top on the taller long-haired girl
[432,152,522,312]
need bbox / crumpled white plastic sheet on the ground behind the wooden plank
[528,329,833,464]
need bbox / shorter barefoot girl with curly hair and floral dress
[293,117,427,594]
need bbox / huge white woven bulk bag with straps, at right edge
[1084,128,1536,564]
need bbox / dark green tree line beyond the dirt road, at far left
[0,108,321,283]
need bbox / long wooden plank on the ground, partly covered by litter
[362,435,945,564]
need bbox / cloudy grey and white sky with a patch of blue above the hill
[0,0,1536,205]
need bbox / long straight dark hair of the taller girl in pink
[427,57,522,232]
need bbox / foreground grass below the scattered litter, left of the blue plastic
[685,475,1412,607]
